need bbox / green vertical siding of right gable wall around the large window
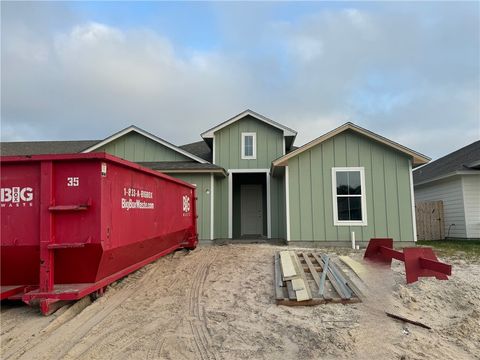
[288,131,413,241]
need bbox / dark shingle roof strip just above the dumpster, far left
[0,140,100,156]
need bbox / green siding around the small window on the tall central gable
[214,116,283,169]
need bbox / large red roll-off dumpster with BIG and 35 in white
[0,153,198,314]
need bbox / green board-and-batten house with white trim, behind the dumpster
[1,110,429,243]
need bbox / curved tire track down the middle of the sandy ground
[187,251,218,360]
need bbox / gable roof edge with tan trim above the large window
[272,122,430,166]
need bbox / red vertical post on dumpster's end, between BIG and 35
[40,161,54,292]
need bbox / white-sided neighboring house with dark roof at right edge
[413,140,480,239]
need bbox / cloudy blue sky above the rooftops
[0,1,480,159]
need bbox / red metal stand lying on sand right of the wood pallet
[364,238,452,284]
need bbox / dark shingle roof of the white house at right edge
[413,140,480,185]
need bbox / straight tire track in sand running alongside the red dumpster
[5,266,163,360]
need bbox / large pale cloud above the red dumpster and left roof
[2,14,251,142]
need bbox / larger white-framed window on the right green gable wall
[332,167,367,226]
